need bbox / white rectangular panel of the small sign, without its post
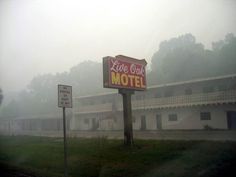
[58,85,72,108]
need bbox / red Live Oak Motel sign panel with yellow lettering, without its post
[103,55,147,90]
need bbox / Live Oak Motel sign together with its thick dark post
[103,55,147,146]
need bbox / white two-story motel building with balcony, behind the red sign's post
[70,74,236,130]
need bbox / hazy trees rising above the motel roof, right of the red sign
[148,34,236,85]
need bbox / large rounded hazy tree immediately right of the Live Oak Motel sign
[150,34,206,83]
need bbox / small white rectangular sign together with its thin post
[58,85,72,177]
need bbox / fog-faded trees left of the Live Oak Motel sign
[0,61,105,118]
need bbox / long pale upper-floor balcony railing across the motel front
[75,90,236,113]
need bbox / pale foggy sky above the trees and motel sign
[0,0,236,92]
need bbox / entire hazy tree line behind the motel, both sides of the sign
[0,33,236,118]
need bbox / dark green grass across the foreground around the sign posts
[0,136,236,177]
